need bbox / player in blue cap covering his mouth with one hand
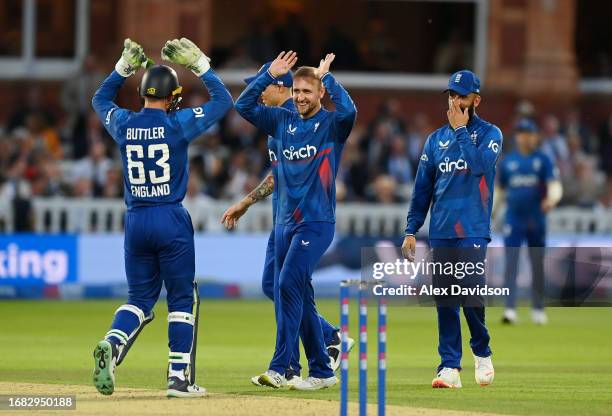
[402,70,502,388]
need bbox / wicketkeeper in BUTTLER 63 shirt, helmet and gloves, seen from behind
[92,38,232,397]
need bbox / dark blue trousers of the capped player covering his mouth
[429,238,491,371]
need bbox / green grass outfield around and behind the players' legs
[0,300,612,415]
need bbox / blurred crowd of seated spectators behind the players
[0,62,612,230]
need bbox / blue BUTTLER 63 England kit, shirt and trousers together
[92,66,233,384]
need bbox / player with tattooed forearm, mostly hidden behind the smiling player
[221,62,355,386]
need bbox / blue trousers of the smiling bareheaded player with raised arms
[269,222,335,378]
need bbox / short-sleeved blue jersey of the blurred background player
[499,150,558,216]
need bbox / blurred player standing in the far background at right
[493,119,563,325]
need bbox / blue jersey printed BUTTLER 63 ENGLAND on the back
[92,69,233,209]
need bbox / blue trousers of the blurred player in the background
[504,216,546,309]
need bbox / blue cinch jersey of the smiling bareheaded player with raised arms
[236,71,357,225]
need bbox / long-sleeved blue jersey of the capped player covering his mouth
[406,115,503,239]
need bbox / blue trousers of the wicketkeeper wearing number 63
[121,204,195,370]
